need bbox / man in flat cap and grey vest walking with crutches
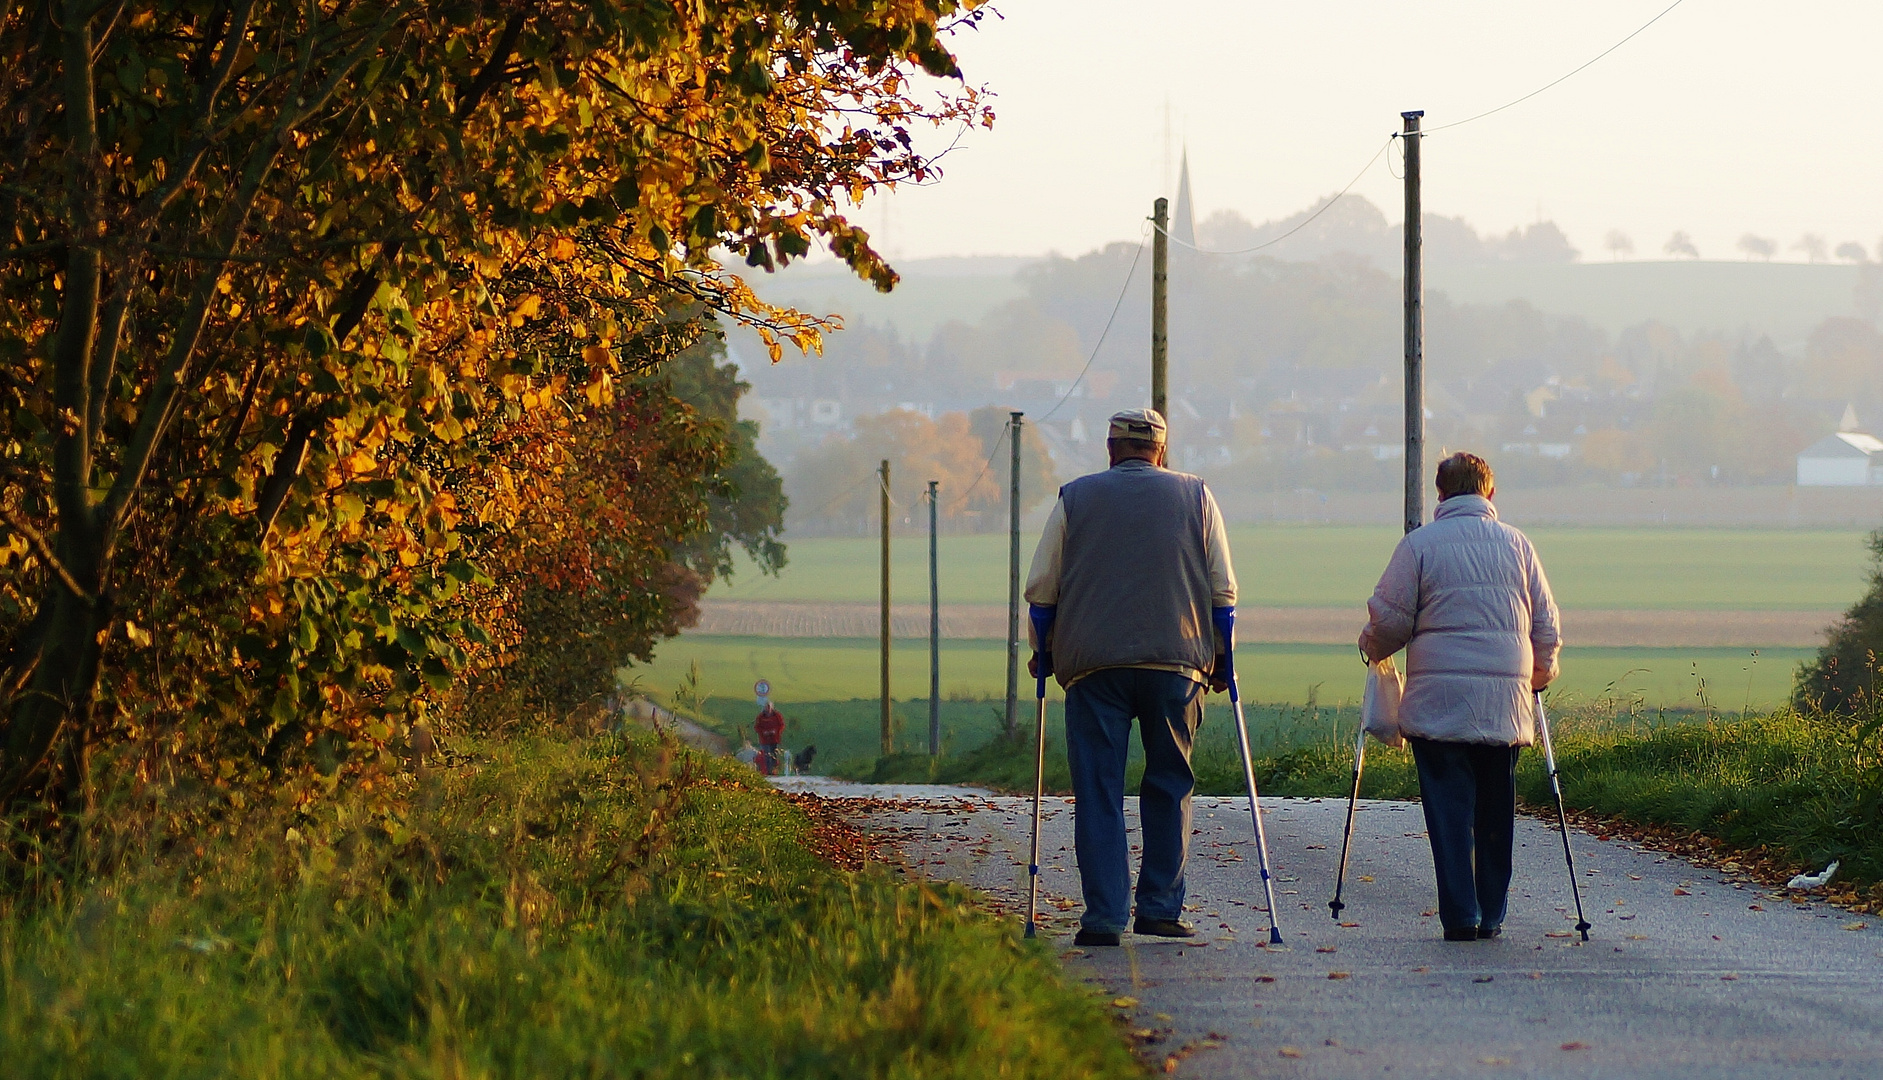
[1026,408,1235,946]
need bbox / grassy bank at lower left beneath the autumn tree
[0,738,1137,1078]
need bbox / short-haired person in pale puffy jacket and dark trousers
[1360,453,1563,941]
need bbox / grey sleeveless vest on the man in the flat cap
[1053,461,1216,685]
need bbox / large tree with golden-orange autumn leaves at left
[0,0,989,807]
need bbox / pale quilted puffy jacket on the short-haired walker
[1360,495,1563,747]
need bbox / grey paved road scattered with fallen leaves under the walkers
[775,779,1883,1080]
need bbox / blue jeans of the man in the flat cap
[1066,668,1203,933]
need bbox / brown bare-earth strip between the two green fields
[689,600,1838,649]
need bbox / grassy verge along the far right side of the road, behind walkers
[870,706,1883,901]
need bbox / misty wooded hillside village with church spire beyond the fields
[734,167,1883,534]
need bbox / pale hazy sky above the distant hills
[859,0,1883,260]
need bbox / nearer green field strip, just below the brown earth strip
[625,636,1813,711]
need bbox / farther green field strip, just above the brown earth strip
[710,525,1868,610]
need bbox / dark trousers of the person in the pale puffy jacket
[1407,736,1518,929]
